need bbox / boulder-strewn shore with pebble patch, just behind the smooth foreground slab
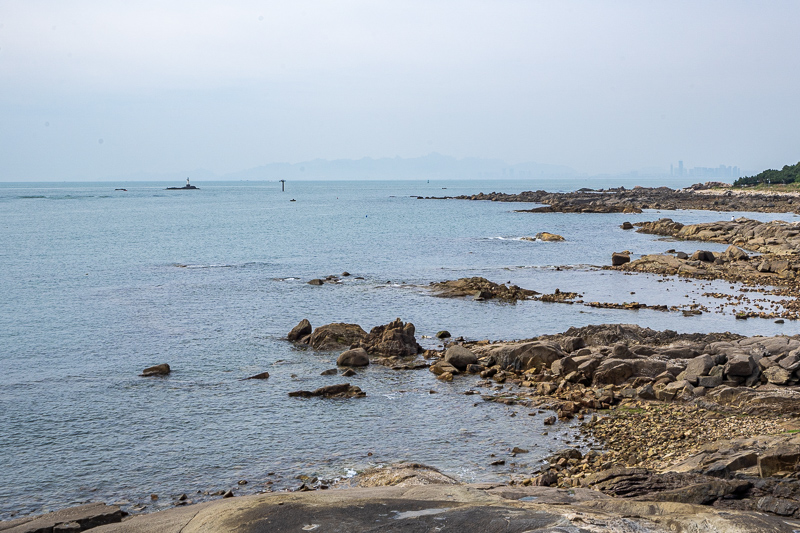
[418,325,800,517]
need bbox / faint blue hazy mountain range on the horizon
[104,153,577,181]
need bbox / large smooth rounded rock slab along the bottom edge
[84,485,798,533]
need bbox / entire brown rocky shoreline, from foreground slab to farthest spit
[9,186,800,533]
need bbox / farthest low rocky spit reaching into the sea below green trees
[432,186,800,213]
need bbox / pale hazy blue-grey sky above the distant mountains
[0,0,800,181]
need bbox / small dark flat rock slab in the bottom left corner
[0,503,122,533]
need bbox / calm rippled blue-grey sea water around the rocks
[0,179,794,519]
